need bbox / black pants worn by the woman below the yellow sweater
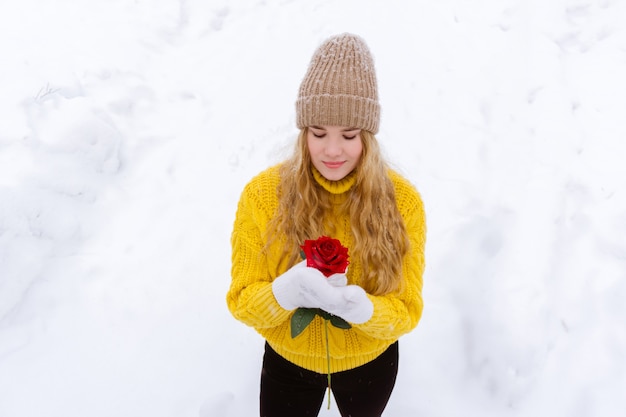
[261,342,398,417]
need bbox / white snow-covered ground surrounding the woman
[0,0,626,417]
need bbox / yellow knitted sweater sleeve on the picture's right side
[355,176,426,341]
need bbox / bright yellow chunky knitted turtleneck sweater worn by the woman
[227,165,426,373]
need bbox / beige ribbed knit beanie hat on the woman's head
[296,33,380,133]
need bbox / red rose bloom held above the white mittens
[300,236,349,277]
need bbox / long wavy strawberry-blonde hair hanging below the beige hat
[267,128,409,295]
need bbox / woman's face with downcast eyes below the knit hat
[306,126,363,181]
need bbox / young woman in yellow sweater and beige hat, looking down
[227,34,426,417]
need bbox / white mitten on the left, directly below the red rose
[272,261,345,310]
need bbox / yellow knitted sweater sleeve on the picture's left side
[226,169,290,329]
